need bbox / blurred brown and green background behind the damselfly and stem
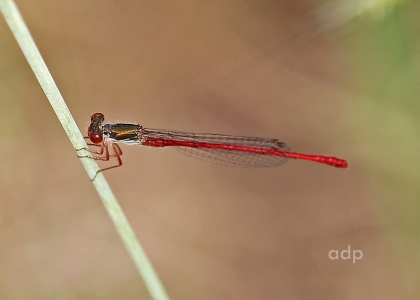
[0,0,420,299]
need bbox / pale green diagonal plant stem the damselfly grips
[0,0,168,299]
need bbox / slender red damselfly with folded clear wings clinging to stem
[79,113,348,176]
